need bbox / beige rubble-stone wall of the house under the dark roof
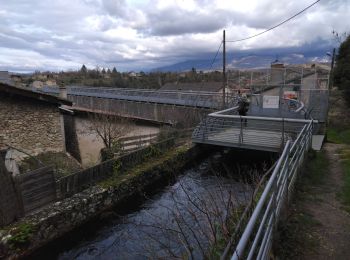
[0,93,64,155]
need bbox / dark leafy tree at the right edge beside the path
[334,33,350,100]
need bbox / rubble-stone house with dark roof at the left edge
[0,82,72,155]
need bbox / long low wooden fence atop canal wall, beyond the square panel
[57,138,175,199]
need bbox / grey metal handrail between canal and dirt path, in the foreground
[228,121,313,260]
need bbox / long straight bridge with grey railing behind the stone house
[36,86,236,124]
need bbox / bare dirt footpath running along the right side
[301,143,350,259]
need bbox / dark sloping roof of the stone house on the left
[0,82,72,106]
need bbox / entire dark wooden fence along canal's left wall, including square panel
[0,135,185,223]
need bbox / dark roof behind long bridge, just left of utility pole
[159,82,223,92]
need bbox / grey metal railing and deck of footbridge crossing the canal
[192,107,306,152]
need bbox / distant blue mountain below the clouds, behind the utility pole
[151,44,332,72]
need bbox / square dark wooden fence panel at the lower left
[14,167,56,214]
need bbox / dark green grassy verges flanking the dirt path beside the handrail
[275,90,350,259]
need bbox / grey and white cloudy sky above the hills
[0,0,350,71]
